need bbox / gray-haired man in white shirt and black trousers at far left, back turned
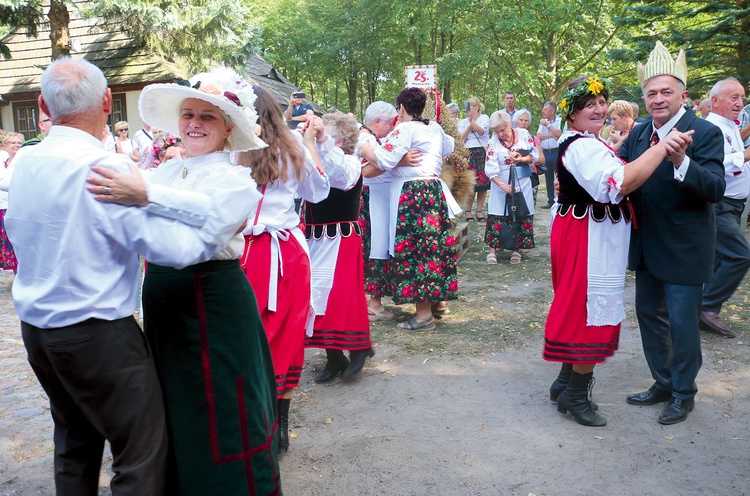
[5,58,223,496]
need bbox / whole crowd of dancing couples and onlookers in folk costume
[0,42,750,495]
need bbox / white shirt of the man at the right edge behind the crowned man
[706,112,750,200]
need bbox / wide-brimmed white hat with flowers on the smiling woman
[138,68,268,151]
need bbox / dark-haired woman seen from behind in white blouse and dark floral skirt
[359,88,461,330]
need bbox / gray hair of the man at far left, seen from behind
[41,57,107,123]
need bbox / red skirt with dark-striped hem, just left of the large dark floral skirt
[305,231,372,350]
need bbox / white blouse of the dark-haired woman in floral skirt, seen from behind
[375,121,454,179]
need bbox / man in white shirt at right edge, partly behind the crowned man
[700,78,750,338]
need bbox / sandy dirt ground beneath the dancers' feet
[0,207,750,496]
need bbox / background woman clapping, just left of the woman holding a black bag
[458,97,490,222]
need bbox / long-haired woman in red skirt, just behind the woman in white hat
[236,86,330,452]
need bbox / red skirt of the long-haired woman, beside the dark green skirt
[245,233,310,398]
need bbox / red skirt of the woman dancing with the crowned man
[543,215,620,364]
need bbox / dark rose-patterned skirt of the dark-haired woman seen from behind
[391,180,458,305]
